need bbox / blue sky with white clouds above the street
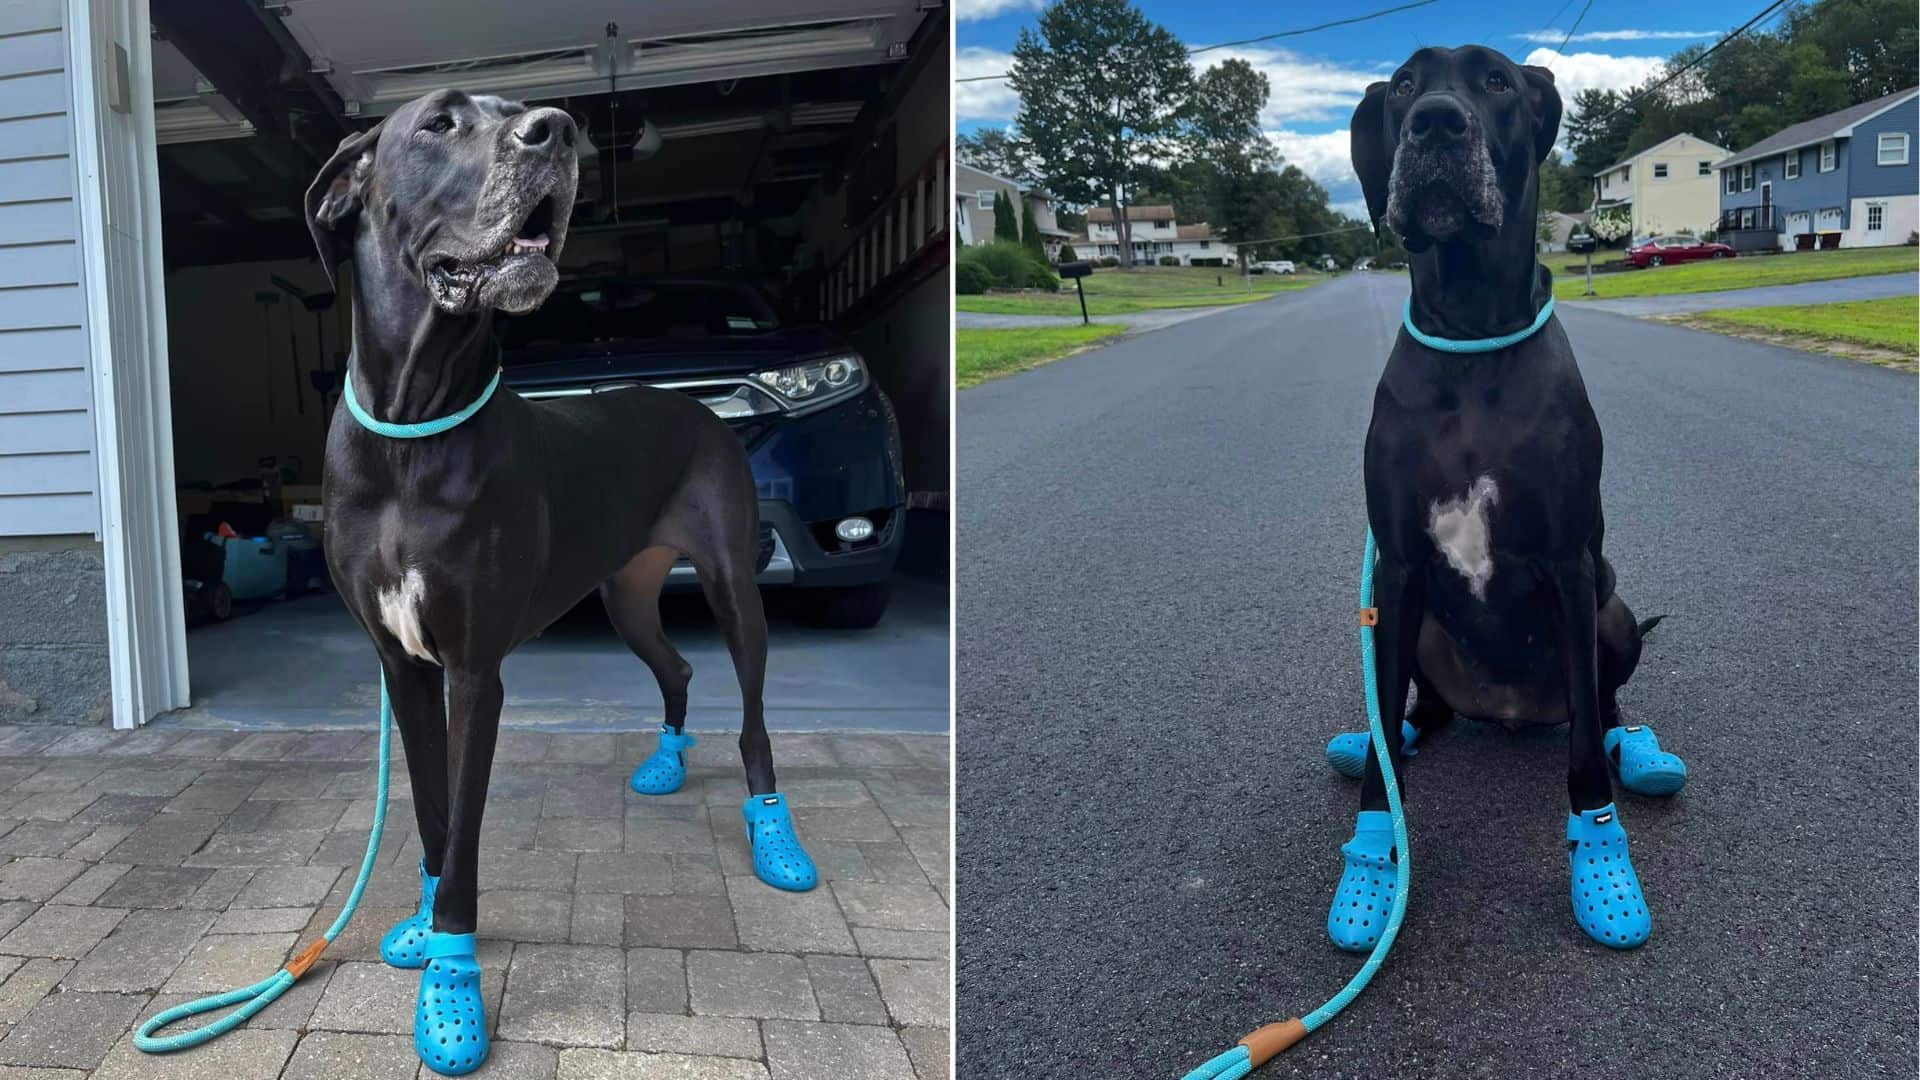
[952,0,1770,213]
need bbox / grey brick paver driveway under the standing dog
[0,714,952,1080]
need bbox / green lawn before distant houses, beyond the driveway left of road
[954,267,1325,315]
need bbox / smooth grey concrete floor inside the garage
[168,575,948,730]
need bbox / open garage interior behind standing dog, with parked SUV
[105,0,948,726]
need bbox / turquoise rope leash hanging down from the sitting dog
[1185,530,1420,1080]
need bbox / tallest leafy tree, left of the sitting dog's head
[1008,0,1192,265]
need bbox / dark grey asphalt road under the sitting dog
[956,275,1920,1080]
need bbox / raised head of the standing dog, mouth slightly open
[307,90,580,315]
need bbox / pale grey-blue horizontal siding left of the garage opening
[0,0,100,536]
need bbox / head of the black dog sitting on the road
[1352,44,1561,252]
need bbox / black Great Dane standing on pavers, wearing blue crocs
[305,90,816,1074]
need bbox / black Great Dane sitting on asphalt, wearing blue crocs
[1327,46,1686,951]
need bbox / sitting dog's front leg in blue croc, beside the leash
[1327,552,1427,953]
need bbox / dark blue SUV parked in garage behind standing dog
[495,277,906,626]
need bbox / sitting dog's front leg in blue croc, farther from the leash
[1548,552,1653,949]
